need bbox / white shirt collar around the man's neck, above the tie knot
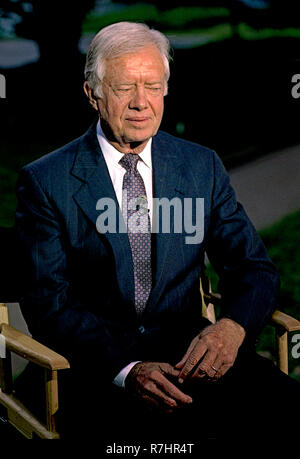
[96,119,152,170]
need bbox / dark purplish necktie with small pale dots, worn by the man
[119,153,152,314]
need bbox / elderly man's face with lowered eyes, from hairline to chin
[97,46,166,152]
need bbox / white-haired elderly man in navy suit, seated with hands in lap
[17,22,298,440]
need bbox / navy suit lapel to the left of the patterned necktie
[71,123,134,306]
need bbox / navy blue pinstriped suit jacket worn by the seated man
[16,124,278,381]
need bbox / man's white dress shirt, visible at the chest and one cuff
[96,120,153,387]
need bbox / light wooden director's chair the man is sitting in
[0,228,300,439]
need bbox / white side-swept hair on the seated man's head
[84,22,170,97]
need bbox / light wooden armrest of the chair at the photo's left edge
[1,324,70,370]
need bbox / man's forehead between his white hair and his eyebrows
[105,46,165,79]
